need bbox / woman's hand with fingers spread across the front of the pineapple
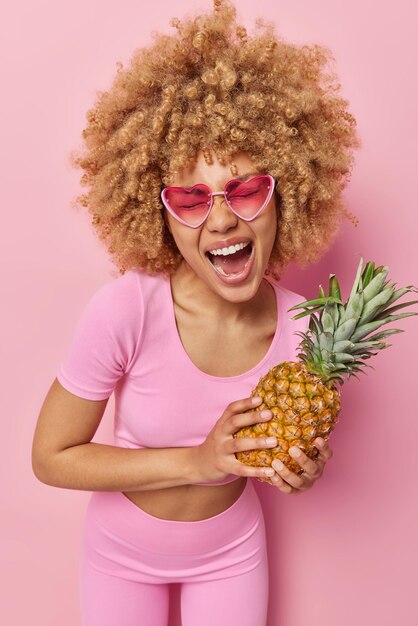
[194,397,277,483]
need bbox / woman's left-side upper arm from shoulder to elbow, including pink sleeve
[32,273,141,477]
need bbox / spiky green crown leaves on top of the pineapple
[289,258,418,384]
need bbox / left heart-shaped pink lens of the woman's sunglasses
[164,185,210,226]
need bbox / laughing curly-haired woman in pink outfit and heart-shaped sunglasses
[33,0,359,626]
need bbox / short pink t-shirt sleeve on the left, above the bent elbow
[57,274,142,400]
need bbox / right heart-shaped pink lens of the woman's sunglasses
[226,176,272,220]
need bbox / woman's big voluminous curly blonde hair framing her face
[71,0,361,279]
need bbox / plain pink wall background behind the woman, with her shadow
[0,0,418,626]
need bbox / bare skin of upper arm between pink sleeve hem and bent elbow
[32,379,109,476]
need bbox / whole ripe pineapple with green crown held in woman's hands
[234,259,418,483]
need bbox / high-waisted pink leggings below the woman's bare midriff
[80,479,268,626]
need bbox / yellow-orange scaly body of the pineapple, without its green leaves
[234,361,341,483]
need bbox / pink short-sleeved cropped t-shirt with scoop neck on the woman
[57,270,308,485]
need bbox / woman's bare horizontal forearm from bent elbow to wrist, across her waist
[34,443,200,491]
